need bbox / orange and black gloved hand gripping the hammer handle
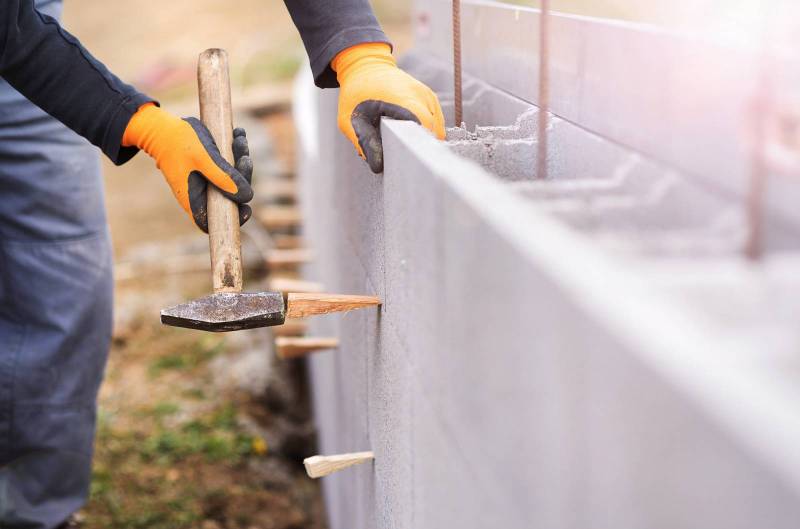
[122,103,253,232]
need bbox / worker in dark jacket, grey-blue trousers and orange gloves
[0,0,444,529]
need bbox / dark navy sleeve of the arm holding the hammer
[0,0,152,164]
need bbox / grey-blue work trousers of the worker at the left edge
[0,0,113,529]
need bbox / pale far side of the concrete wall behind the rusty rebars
[415,0,800,241]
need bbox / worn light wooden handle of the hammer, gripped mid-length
[197,49,242,292]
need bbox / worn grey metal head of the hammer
[161,292,286,332]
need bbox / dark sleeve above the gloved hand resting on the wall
[284,0,391,88]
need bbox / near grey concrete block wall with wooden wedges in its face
[297,34,800,529]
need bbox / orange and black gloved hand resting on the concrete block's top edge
[331,42,444,173]
